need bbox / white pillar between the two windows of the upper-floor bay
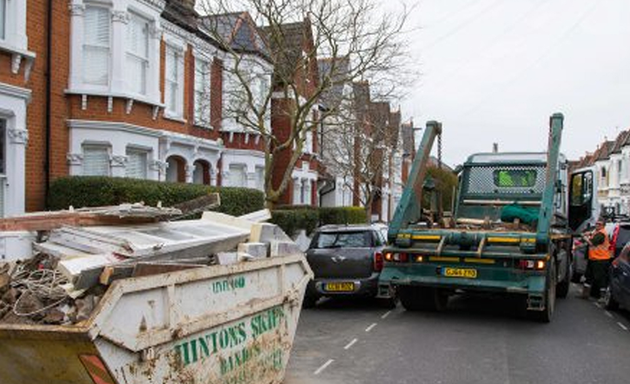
[111,7,129,93]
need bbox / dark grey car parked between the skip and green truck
[304,225,395,307]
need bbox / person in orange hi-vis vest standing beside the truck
[582,219,612,299]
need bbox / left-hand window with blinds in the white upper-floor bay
[83,6,111,86]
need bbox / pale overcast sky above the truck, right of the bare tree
[379,0,630,164]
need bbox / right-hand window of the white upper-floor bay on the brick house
[126,13,149,95]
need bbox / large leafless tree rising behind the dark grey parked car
[197,0,409,206]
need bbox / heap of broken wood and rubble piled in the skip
[0,195,300,325]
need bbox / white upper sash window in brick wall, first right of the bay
[164,46,184,118]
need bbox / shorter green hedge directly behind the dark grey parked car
[271,205,366,236]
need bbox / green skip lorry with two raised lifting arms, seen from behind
[379,114,592,322]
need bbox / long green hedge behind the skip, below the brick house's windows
[48,176,265,216]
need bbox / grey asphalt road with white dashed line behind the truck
[284,286,630,384]
